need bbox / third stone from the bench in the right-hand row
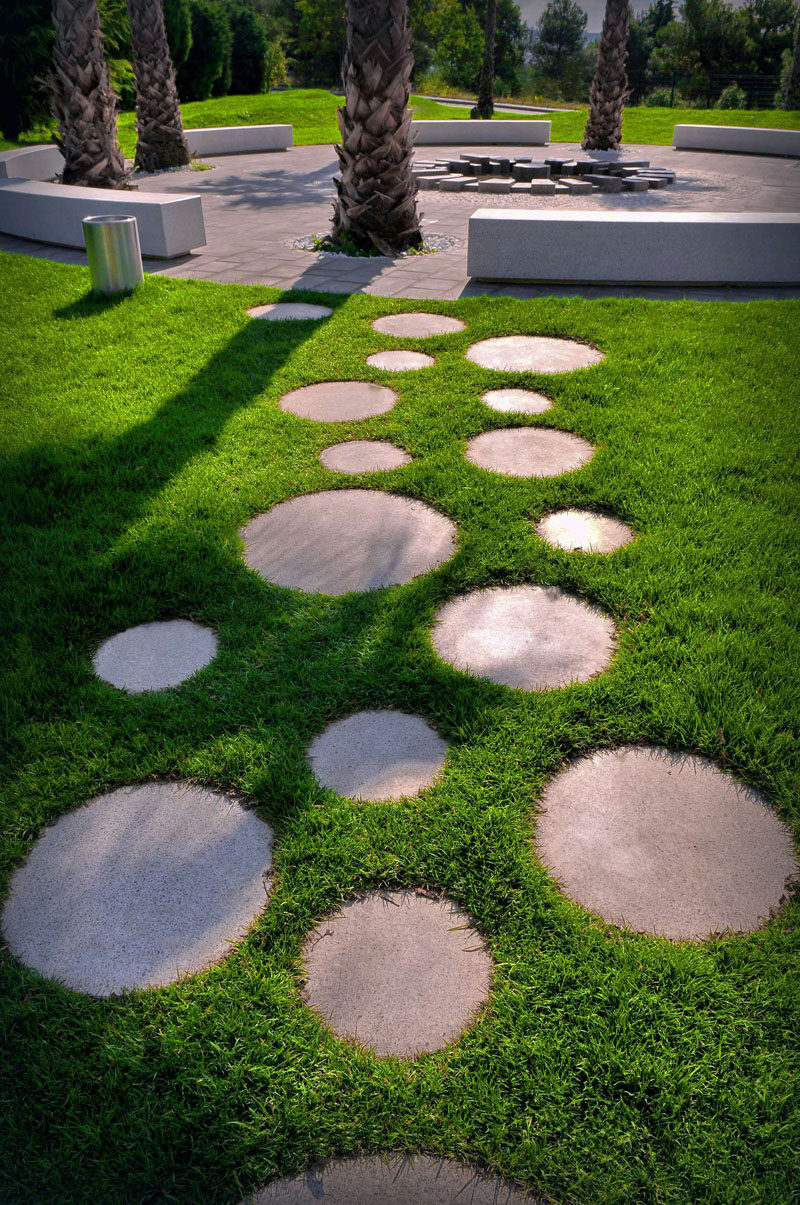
[466,427,594,477]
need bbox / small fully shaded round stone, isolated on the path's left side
[93,619,217,694]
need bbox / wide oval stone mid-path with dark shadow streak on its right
[241,489,455,594]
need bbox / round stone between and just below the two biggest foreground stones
[304,890,493,1058]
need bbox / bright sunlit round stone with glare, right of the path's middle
[433,586,617,690]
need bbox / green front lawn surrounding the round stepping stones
[0,255,800,1205]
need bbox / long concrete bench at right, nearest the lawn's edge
[466,210,800,284]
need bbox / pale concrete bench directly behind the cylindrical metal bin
[0,180,206,259]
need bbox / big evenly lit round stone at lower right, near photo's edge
[535,746,798,940]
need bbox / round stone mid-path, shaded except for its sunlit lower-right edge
[308,711,447,800]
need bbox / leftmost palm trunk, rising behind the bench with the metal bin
[49,0,125,188]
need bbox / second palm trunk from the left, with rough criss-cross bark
[127,0,190,171]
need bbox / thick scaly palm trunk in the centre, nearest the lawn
[334,0,422,255]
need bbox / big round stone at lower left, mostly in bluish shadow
[2,782,272,995]
